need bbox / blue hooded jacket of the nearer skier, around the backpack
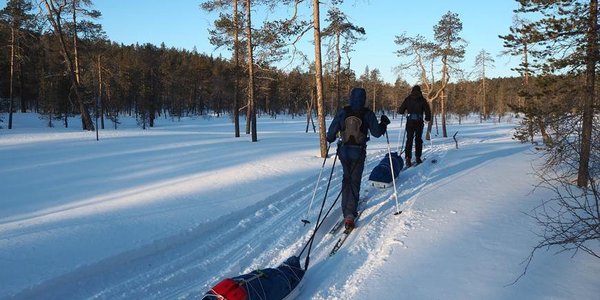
[327,88,386,159]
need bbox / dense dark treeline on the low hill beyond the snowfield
[0,0,517,129]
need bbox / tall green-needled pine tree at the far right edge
[508,0,599,187]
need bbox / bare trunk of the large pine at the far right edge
[577,0,598,187]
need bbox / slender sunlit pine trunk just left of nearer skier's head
[313,0,327,158]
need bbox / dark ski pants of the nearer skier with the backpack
[340,148,367,219]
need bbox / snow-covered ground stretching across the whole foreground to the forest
[0,114,600,299]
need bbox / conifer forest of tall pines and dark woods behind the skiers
[0,0,599,185]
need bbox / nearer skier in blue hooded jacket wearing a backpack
[327,88,390,230]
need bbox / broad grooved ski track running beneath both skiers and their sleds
[14,137,436,299]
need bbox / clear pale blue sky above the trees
[2,0,518,84]
